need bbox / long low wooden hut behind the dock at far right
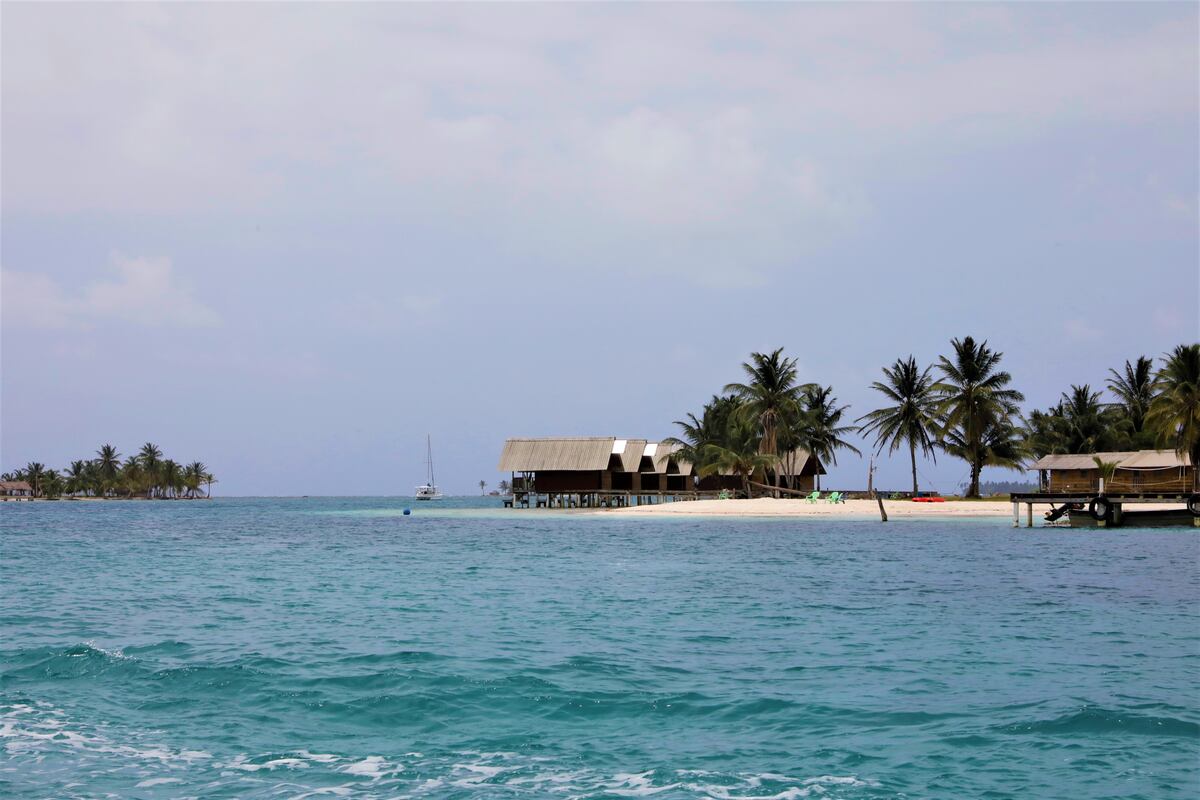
[1030,450,1198,494]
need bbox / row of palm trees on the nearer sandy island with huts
[666,336,1200,498]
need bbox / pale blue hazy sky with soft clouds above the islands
[0,2,1200,495]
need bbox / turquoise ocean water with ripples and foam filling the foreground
[0,498,1200,800]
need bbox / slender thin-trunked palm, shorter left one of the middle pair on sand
[857,355,938,495]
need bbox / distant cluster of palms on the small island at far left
[0,441,216,500]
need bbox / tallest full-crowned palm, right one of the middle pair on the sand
[934,336,1025,498]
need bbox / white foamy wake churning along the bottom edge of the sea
[0,703,880,800]
